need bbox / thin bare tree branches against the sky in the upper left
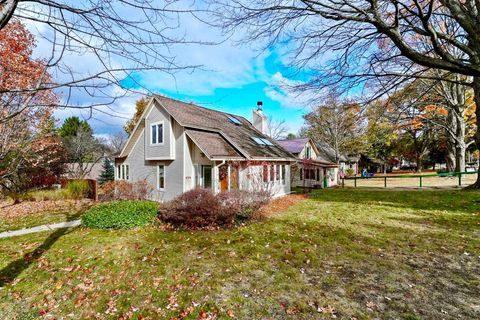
[0,0,206,122]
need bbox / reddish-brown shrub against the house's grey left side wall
[102,180,153,200]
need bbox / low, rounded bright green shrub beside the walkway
[82,201,158,229]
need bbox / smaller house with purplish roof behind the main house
[277,138,338,188]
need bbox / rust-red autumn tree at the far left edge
[0,21,63,199]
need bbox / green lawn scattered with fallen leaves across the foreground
[0,189,480,319]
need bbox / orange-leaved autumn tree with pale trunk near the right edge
[388,75,475,172]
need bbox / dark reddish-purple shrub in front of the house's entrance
[158,189,270,229]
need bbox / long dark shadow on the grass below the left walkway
[0,210,82,288]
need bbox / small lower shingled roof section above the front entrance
[185,129,243,160]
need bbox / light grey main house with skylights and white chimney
[115,95,295,201]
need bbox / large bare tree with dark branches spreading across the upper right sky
[217,0,480,188]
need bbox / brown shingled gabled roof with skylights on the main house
[121,95,295,160]
